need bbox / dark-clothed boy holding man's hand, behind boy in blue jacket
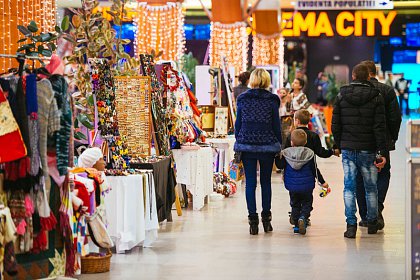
[284,109,340,192]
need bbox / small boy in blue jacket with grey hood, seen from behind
[276,129,325,234]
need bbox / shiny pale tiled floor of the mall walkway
[81,123,405,280]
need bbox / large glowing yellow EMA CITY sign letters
[281,11,397,37]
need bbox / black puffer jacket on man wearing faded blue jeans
[332,81,386,152]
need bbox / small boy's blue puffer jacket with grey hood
[281,147,316,192]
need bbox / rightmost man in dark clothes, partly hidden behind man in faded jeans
[356,60,401,230]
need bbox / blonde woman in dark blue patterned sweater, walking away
[234,69,281,235]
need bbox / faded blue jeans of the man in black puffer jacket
[342,150,378,225]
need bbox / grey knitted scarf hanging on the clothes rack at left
[37,79,60,196]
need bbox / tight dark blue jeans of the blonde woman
[242,158,274,215]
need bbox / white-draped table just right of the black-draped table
[172,147,213,210]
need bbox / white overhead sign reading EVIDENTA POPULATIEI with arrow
[295,0,394,11]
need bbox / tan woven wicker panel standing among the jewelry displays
[115,77,151,157]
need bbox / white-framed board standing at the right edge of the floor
[405,158,420,280]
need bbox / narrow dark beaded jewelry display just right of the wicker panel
[140,54,170,156]
